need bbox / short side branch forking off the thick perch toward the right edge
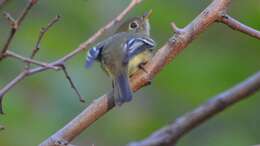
[218,13,260,39]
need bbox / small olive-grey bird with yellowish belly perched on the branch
[85,11,155,105]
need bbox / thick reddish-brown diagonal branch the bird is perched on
[38,0,230,146]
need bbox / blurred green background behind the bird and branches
[0,0,260,146]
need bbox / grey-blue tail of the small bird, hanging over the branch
[113,73,132,105]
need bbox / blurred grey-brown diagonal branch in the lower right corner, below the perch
[128,72,260,146]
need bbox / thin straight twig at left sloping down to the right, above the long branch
[5,51,59,70]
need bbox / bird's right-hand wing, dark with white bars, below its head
[124,36,155,63]
